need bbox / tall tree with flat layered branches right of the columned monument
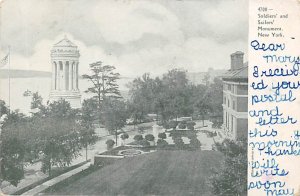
[82,61,121,120]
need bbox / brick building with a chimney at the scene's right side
[222,51,248,140]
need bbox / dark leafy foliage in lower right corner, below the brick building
[210,139,248,196]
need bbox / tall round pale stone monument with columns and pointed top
[50,36,81,108]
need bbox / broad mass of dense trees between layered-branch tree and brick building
[128,69,223,122]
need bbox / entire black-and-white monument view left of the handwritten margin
[0,0,249,196]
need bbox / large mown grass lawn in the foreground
[46,150,222,195]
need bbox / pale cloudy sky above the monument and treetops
[0,0,248,77]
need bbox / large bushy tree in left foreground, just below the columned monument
[21,100,82,175]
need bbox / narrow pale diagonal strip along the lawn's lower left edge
[22,162,91,195]
